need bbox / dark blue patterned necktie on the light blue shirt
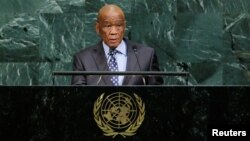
[108,49,119,86]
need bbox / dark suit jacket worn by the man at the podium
[71,39,163,85]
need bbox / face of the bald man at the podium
[96,11,126,48]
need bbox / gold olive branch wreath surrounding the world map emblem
[93,93,145,138]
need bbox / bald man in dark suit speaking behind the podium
[72,4,163,85]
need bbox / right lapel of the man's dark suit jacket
[123,40,138,85]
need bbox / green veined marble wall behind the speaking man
[0,0,250,85]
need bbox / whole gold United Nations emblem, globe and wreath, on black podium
[93,92,145,138]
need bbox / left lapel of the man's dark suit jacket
[91,42,112,85]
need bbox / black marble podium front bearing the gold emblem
[0,86,250,141]
